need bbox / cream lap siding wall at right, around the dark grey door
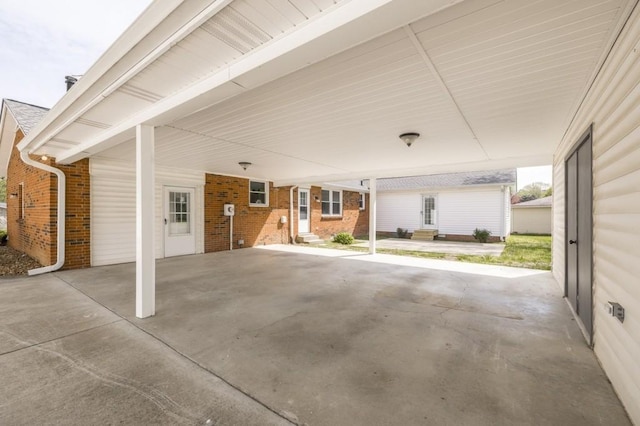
[553,8,640,424]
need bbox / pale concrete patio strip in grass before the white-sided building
[354,238,505,256]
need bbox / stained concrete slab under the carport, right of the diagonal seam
[51,248,630,425]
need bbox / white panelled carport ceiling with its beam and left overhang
[13,0,634,184]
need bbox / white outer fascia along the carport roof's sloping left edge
[18,0,184,152]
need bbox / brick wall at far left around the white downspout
[7,130,91,269]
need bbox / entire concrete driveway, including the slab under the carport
[0,246,630,425]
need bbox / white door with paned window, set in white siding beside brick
[164,187,196,257]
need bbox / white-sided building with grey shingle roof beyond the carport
[376,169,516,241]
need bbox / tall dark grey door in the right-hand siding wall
[565,125,593,344]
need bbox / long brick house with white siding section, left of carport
[0,99,369,268]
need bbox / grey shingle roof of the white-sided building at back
[377,169,516,191]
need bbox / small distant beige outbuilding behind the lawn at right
[511,196,553,235]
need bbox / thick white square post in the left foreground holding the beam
[136,124,156,318]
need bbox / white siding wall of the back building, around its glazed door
[376,188,503,236]
